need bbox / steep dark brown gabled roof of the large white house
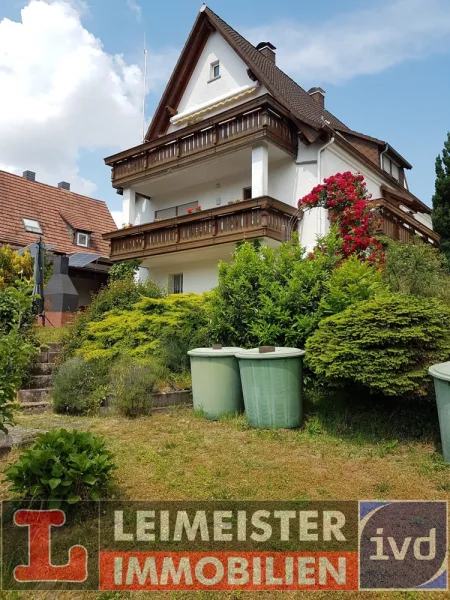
[145,6,348,141]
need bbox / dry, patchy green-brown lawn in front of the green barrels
[0,399,450,600]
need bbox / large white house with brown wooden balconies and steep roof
[105,6,439,292]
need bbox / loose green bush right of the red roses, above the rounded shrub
[383,238,450,304]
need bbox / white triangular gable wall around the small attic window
[168,33,267,133]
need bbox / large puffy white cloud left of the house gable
[0,0,173,195]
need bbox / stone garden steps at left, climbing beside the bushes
[17,343,62,412]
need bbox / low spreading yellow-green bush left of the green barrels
[79,294,209,371]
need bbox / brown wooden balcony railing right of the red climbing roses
[374,198,440,246]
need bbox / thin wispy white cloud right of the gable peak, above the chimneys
[246,0,450,85]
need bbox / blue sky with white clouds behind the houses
[0,0,450,220]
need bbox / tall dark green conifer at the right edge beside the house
[432,132,450,262]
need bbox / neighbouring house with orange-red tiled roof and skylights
[0,171,116,308]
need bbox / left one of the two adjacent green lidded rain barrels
[188,346,244,419]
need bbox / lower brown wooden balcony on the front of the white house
[103,196,298,261]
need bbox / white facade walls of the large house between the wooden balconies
[118,27,431,292]
